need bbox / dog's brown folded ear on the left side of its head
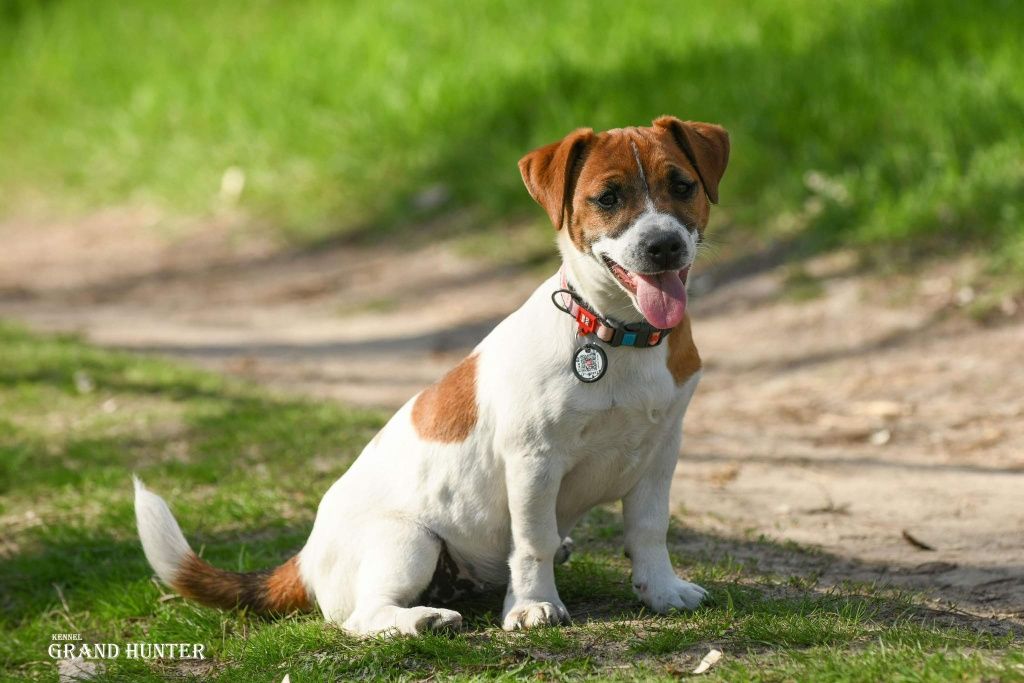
[519,128,595,229]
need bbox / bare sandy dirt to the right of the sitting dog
[673,259,1024,624]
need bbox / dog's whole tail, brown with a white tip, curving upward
[132,477,312,614]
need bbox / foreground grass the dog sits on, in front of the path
[0,326,1024,681]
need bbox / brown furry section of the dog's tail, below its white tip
[173,553,311,614]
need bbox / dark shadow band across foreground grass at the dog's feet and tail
[0,509,1024,646]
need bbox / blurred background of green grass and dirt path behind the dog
[0,0,1024,630]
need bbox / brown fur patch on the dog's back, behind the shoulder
[413,354,476,443]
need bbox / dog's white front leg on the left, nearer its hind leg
[502,453,569,631]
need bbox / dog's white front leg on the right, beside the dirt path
[623,429,708,614]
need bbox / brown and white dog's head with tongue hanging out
[519,117,729,329]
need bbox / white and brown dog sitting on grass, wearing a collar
[135,117,729,635]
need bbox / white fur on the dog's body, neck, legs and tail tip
[136,222,706,634]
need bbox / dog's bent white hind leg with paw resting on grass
[342,519,462,636]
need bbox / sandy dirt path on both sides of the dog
[0,212,1024,628]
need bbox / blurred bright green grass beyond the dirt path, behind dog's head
[0,0,1024,271]
